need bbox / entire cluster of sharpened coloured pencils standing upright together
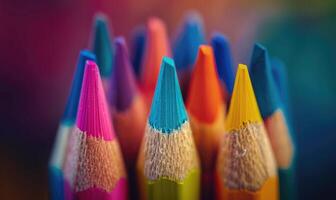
[49,12,295,200]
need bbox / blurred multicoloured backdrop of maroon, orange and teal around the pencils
[0,0,336,200]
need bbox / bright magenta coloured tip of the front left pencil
[76,61,114,140]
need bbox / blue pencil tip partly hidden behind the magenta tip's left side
[62,50,96,124]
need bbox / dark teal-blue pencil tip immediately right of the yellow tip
[250,44,281,118]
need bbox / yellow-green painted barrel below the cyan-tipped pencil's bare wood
[147,170,200,200]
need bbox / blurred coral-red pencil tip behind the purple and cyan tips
[140,17,171,110]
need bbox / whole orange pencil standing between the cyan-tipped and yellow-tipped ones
[186,45,226,199]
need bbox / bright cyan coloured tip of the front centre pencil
[149,57,188,134]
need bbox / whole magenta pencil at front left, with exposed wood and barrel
[65,61,128,200]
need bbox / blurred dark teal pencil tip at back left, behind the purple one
[91,13,114,91]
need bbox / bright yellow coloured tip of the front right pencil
[226,64,262,131]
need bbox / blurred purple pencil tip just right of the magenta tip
[109,37,137,111]
